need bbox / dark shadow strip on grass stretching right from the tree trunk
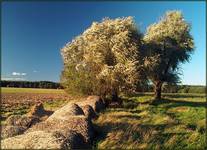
[151,99,207,107]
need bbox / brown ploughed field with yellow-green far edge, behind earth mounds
[1,88,84,121]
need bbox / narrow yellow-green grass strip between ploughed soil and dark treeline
[1,87,64,94]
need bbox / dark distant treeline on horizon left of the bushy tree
[1,80,62,89]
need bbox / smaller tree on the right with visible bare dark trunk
[143,11,194,99]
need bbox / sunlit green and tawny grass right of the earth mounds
[94,94,206,149]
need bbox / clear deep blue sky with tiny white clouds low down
[1,2,206,85]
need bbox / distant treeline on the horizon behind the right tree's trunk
[145,85,206,93]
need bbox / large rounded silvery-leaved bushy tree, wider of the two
[61,17,146,98]
